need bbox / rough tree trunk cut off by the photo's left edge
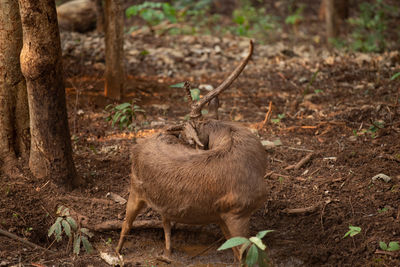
[0,0,30,176]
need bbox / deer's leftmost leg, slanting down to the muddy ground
[116,191,146,253]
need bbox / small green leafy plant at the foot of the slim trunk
[105,99,145,130]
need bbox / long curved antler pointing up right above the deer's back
[190,40,253,119]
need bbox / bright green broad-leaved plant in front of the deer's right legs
[218,230,274,267]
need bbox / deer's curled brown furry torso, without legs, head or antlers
[132,121,266,224]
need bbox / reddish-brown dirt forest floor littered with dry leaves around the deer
[0,1,400,266]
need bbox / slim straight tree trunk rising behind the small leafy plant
[104,0,125,100]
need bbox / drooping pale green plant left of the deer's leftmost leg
[48,205,93,255]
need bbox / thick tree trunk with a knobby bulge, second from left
[19,0,81,189]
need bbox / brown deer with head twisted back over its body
[116,41,267,261]
